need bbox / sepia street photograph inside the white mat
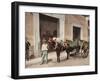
[25,12,90,68]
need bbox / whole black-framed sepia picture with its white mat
[11,2,97,79]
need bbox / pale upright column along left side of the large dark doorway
[33,13,40,57]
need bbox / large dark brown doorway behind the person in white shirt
[39,14,59,41]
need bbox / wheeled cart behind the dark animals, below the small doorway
[65,40,89,58]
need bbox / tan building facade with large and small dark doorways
[25,12,89,57]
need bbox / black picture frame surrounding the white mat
[11,2,98,79]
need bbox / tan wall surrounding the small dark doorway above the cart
[64,15,89,41]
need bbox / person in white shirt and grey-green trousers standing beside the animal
[41,39,48,64]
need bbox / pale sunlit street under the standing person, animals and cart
[26,51,89,68]
